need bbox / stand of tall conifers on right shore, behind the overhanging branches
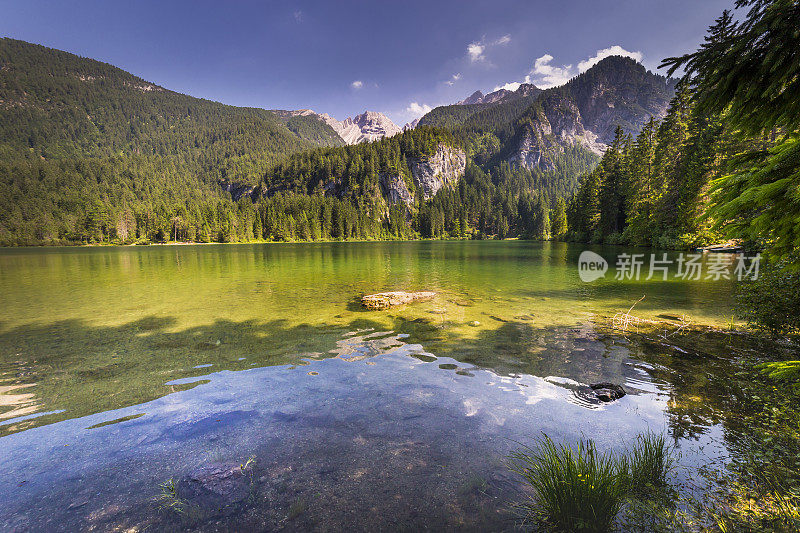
[568,85,737,248]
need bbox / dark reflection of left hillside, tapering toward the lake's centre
[0,317,356,434]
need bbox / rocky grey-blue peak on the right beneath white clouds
[419,56,676,169]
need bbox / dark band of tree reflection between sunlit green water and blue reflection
[0,316,660,433]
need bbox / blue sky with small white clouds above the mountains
[0,0,733,126]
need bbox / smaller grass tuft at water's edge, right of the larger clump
[624,432,675,495]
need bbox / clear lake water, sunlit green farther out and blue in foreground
[0,242,731,530]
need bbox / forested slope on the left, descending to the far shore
[0,39,342,245]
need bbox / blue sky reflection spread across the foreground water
[0,331,723,529]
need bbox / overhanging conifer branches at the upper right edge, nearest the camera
[664,0,800,269]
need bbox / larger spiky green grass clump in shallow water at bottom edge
[509,435,628,532]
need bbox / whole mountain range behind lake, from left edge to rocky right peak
[0,39,674,245]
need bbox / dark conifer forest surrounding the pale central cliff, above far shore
[256,126,597,239]
